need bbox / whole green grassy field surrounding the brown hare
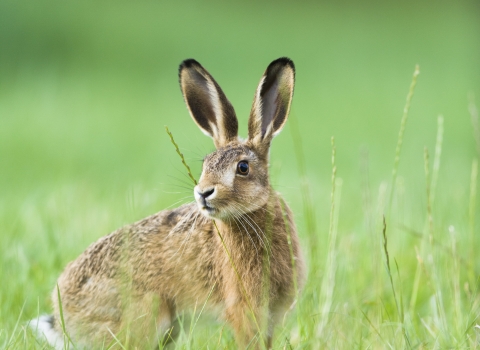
[0,0,480,349]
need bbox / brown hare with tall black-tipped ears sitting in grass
[30,58,304,349]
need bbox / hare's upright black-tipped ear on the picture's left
[179,59,238,148]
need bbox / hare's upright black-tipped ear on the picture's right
[248,57,295,149]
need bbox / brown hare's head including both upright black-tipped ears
[179,58,295,219]
